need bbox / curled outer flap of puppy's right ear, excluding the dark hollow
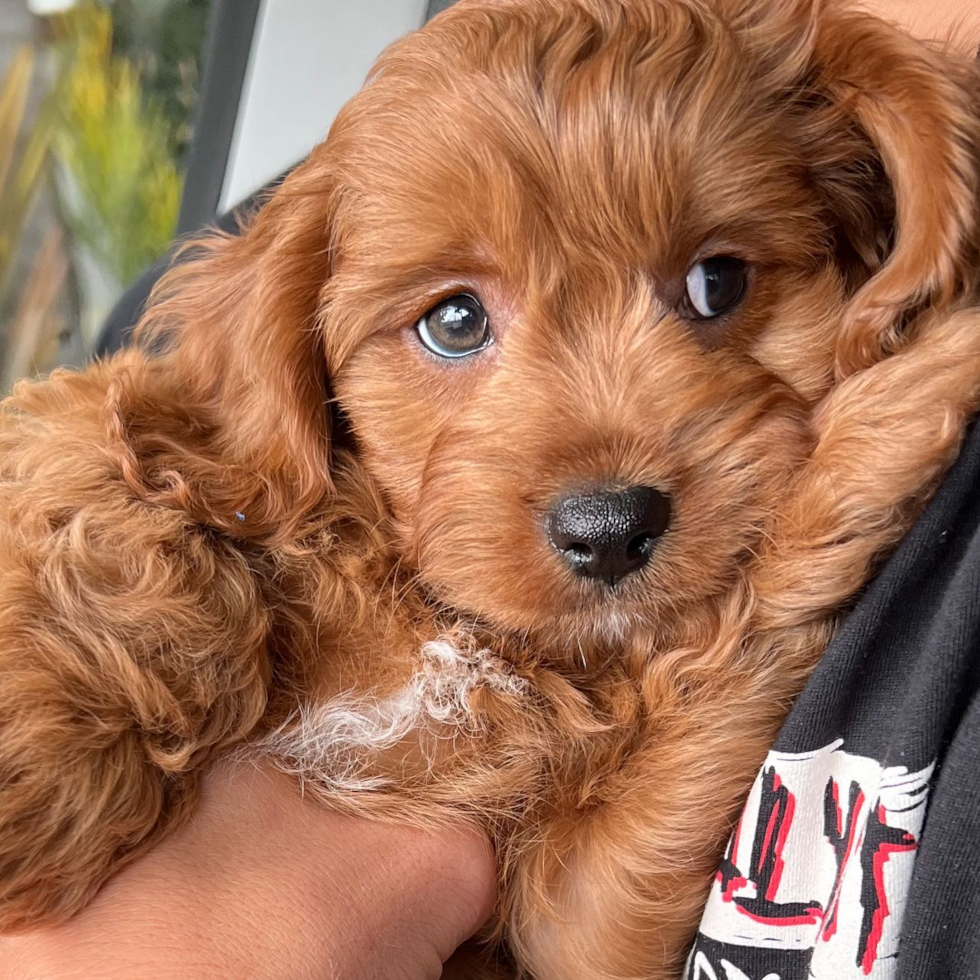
[816,5,980,377]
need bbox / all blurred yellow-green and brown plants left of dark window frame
[0,0,199,394]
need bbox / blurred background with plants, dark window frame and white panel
[0,0,452,396]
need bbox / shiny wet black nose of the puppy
[548,487,670,586]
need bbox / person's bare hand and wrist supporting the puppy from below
[0,767,495,980]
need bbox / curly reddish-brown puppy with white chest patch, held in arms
[0,0,980,980]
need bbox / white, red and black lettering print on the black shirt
[685,740,934,980]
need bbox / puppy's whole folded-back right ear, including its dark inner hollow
[736,0,980,377]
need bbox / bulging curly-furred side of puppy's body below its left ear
[0,360,269,932]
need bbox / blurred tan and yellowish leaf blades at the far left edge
[0,46,67,394]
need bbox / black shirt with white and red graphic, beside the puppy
[685,425,980,980]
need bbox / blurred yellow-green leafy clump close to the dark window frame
[54,0,181,286]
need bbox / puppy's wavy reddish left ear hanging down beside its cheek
[119,160,332,540]
